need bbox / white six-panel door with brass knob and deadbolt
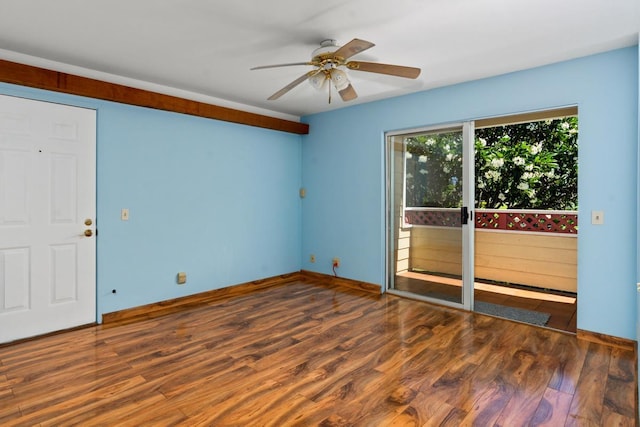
[0,95,96,342]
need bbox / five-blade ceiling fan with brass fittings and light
[251,39,420,102]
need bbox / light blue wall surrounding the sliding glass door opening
[302,46,638,339]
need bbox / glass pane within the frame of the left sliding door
[389,128,463,303]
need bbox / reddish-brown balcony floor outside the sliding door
[395,273,577,333]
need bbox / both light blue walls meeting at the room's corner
[0,46,639,339]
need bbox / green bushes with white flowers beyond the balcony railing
[406,117,578,210]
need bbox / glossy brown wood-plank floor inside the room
[0,281,637,426]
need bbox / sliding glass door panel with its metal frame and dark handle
[386,122,473,309]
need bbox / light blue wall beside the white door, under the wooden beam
[0,84,301,320]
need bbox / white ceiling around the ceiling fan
[0,0,640,119]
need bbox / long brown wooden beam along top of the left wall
[0,59,309,135]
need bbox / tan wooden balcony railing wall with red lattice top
[397,208,578,292]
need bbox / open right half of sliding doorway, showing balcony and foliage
[474,117,578,332]
